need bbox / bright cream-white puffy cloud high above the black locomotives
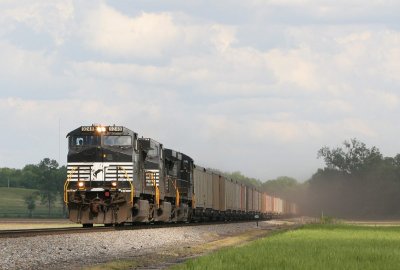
[81,4,179,58]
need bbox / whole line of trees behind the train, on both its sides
[0,139,400,218]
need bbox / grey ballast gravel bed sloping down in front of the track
[0,221,282,269]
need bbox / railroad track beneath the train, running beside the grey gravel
[0,220,262,238]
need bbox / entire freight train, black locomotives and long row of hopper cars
[64,124,297,227]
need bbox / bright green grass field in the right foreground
[172,224,400,270]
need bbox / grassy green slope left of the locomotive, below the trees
[0,187,62,218]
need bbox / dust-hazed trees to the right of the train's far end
[216,139,400,219]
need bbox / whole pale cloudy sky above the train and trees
[0,0,400,181]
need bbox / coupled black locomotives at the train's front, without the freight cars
[64,125,193,227]
